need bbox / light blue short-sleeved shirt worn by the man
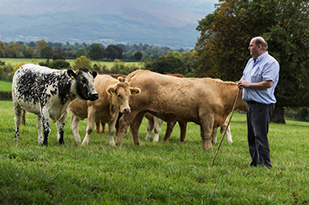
[242,51,280,104]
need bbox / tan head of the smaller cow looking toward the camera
[106,82,141,114]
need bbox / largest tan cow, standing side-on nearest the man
[117,70,242,149]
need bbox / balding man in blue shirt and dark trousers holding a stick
[238,37,280,168]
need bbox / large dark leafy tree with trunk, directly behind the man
[196,0,309,123]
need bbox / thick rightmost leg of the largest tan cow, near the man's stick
[200,115,214,150]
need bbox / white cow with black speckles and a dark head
[12,64,98,145]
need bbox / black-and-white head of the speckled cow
[67,68,99,101]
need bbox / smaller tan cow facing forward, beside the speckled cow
[70,75,140,146]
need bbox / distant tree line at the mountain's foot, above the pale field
[0,40,180,61]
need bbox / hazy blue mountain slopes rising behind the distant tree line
[0,0,217,48]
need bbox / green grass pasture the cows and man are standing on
[0,101,309,204]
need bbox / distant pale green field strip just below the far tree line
[0,58,144,68]
